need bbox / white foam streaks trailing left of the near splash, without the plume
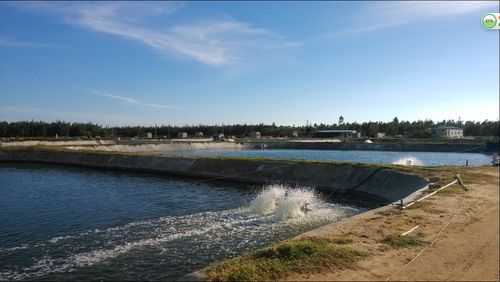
[0,209,257,280]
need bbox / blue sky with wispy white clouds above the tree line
[0,1,500,125]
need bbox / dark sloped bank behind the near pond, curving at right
[0,148,428,205]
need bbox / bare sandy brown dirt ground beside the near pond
[289,167,500,281]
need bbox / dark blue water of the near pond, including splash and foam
[0,164,363,281]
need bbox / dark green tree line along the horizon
[0,118,499,138]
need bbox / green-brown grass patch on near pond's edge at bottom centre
[206,239,366,281]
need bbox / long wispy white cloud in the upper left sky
[12,2,297,66]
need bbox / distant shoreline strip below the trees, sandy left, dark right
[0,138,498,154]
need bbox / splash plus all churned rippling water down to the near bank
[0,185,360,280]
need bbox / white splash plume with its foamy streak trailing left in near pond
[0,185,359,280]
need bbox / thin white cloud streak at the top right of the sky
[328,1,499,37]
